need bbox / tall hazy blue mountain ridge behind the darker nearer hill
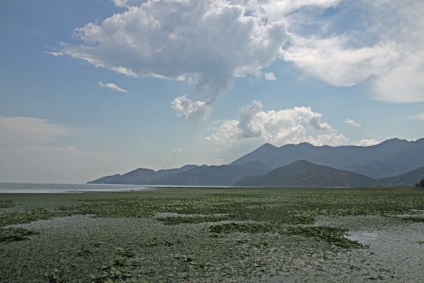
[230,139,424,178]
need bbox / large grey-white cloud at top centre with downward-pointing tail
[63,0,287,101]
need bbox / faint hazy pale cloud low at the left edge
[0,116,76,147]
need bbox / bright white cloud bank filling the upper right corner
[284,0,424,103]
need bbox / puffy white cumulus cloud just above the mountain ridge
[206,101,347,145]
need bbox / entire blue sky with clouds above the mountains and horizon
[0,0,424,183]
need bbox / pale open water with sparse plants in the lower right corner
[312,216,424,282]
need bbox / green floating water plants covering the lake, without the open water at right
[0,188,424,282]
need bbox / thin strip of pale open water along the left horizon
[0,183,151,194]
